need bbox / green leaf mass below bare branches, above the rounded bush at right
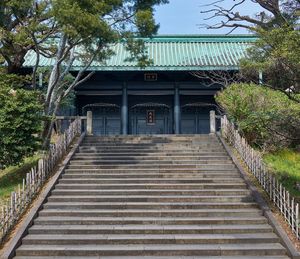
[241,26,300,102]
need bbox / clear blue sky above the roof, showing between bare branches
[155,0,261,34]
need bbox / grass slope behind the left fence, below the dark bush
[0,155,40,205]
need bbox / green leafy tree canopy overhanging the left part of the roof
[0,0,168,74]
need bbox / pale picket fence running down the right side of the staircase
[221,115,300,239]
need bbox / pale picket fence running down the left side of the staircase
[0,118,81,244]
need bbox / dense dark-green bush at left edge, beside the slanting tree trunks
[0,75,42,167]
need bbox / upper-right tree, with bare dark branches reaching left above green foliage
[203,0,300,102]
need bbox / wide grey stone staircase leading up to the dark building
[15,135,288,259]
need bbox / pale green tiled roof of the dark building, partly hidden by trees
[24,35,256,71]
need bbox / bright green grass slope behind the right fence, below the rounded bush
[264,149,300,200]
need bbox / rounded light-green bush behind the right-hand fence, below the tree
[216,84,300,149]
